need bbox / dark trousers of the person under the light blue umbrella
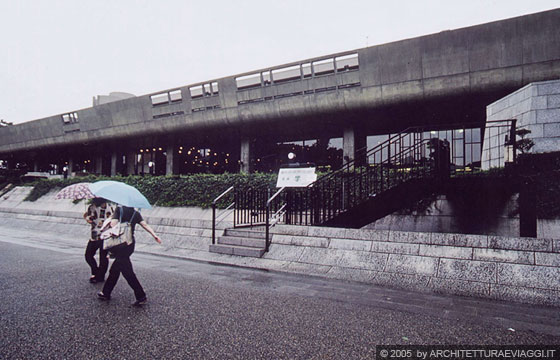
[102,243,146,300]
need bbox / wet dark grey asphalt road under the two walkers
[0,239,560,359]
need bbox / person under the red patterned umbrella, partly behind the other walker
[84,198,114,283]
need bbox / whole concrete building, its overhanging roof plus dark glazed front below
[0,9,560,175]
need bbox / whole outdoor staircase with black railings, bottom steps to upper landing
[210,120,516,257]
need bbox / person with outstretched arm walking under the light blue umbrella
[97,206,161,306]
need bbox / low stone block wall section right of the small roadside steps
[264,225,560,306]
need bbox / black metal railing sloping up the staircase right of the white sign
[286,134,436,225]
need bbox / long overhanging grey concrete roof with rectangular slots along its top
[0,9,560,154]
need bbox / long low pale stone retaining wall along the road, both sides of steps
[0,186,560,306]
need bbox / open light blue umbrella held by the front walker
[89,180,152,209]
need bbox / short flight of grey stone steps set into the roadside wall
[210,228,266,258]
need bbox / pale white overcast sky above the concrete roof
[0,0,560,123]
